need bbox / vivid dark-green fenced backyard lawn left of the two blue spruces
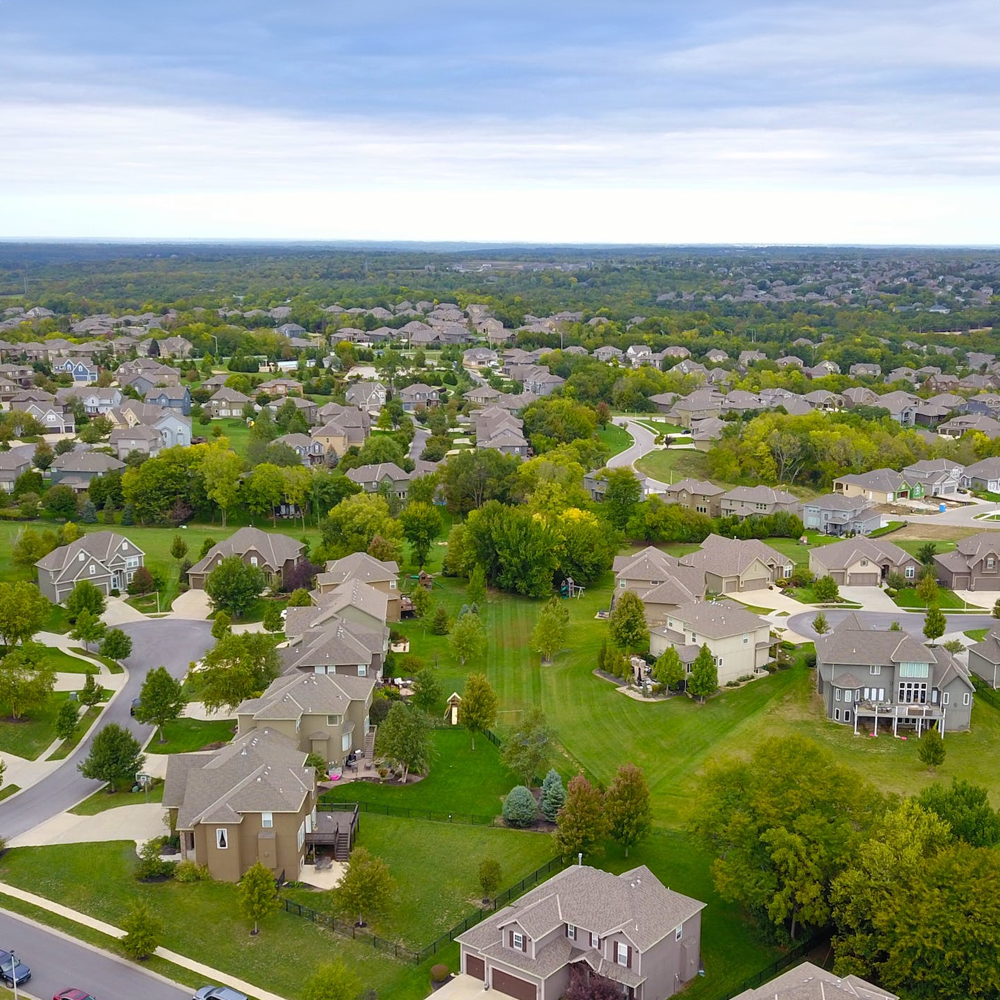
[323,732,520,816]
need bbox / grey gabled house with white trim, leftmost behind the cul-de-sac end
[35,532,145,604]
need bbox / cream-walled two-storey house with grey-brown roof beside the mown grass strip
[649,600,777,687]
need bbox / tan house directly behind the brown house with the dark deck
[236,671,375,767]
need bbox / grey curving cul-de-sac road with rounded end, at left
[0,618,212,840]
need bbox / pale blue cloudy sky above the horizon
[0,0,1000,245]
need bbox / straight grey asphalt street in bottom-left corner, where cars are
[0,911,191,1000]
